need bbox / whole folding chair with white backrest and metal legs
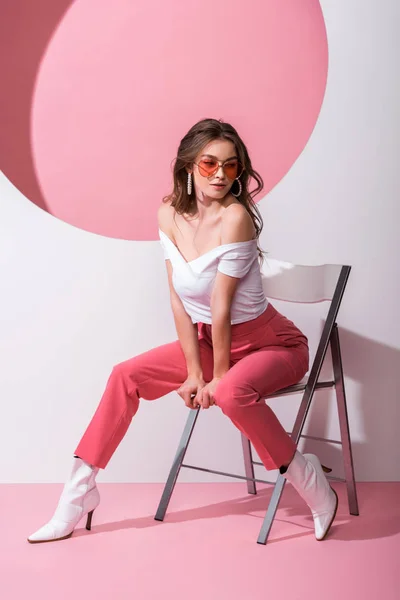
[154,258,359,544]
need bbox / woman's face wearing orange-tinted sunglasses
[188,140,240,200]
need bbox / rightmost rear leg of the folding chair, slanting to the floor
[331,324,360,515]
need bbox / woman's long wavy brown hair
[163,119,264,261]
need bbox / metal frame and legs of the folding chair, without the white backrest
[154,265,359,545]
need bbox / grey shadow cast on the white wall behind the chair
[302,326,400,481]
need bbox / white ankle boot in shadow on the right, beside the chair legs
[283,450,338,541]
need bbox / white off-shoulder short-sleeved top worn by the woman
[158,228,268,325]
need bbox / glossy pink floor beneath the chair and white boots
[0,482,400,600]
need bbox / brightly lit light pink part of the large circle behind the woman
[2,0,328,240]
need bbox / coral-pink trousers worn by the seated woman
[75,304,309,470]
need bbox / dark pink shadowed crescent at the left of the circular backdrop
[0,0,74,212]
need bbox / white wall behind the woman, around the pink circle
[0,0,400,482]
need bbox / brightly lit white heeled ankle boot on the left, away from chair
[28,458,100,544]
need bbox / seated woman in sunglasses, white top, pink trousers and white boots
[28,119,338,543]
